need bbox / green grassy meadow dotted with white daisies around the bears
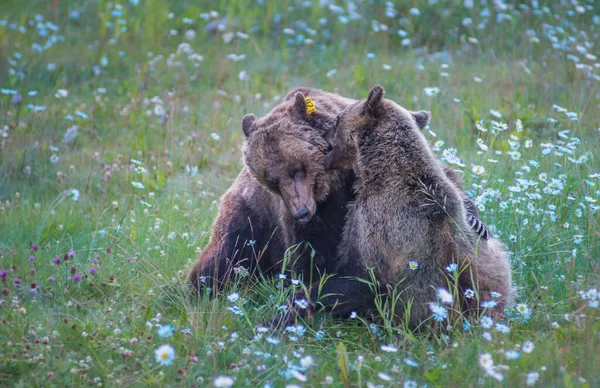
[0,0,600,387]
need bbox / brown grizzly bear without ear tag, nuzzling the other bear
[290,86,513,328]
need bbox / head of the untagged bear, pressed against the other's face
[324,85,431,170]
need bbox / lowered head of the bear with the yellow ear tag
[242,89,341,224]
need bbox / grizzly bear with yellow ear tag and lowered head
[188,88,487,298]
